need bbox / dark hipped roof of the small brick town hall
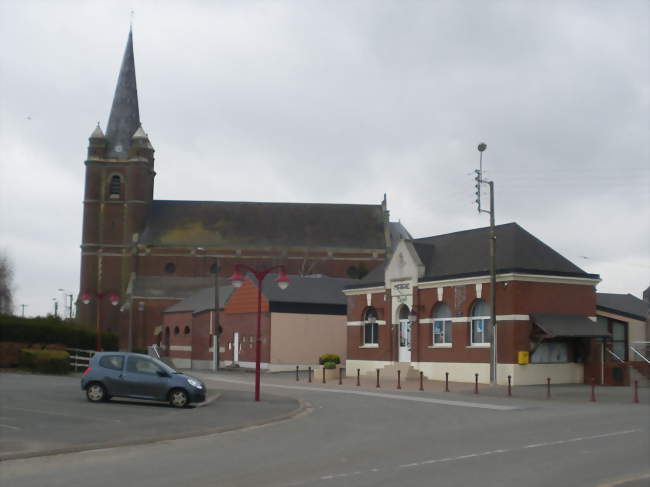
[413,223,598,281]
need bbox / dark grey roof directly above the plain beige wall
[253,275,359,305]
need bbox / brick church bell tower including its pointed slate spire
[77,31,155,348]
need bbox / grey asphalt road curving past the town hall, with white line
[0,374,650,487]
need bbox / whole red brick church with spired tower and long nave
[77,31,410,350]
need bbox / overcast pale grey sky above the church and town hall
[0,0,650,315]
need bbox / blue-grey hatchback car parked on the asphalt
[81,352,206,408]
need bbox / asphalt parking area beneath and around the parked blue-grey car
[0,373,300,460]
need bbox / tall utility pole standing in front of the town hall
[474,142,497,385]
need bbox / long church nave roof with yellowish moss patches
[140,200,386,250]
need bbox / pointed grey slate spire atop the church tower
[106,29,140,159]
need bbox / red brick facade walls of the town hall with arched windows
[348,281,596,363]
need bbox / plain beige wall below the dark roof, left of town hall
[271,313,347,366]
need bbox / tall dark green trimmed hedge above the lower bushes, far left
[0,316,118,350]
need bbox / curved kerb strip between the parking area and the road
[0,393,312,462]
